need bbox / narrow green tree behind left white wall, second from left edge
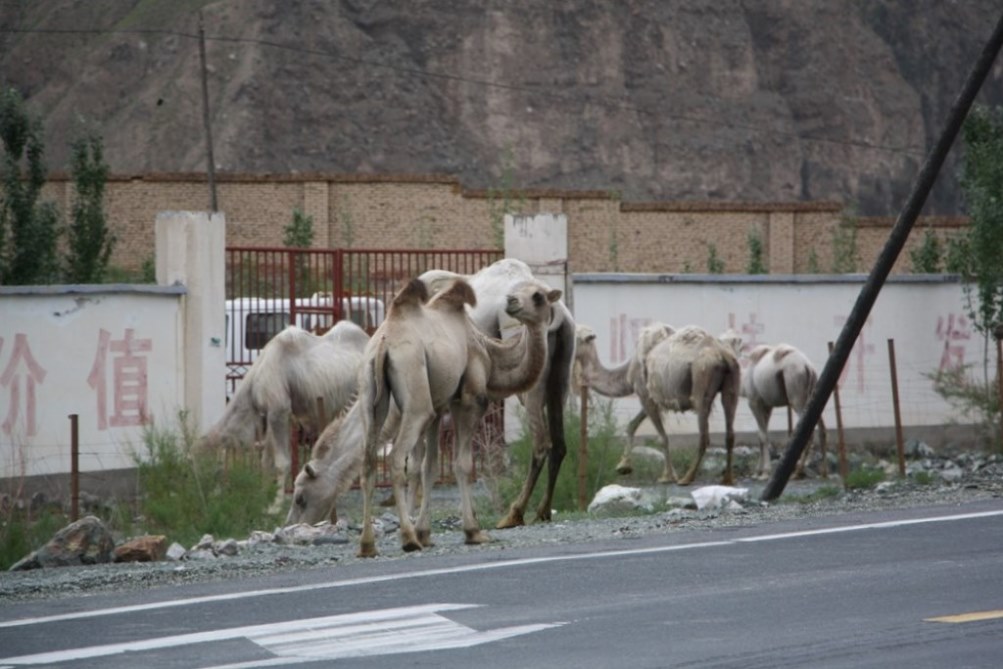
[66,134,115,284]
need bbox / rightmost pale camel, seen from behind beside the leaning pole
[741,344,828,478]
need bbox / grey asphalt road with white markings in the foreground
[0,499,1003,669]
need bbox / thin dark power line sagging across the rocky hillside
[0,28,927,155]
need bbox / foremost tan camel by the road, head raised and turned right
[358,279,561,557]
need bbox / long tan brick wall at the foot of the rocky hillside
[37,175,967,274]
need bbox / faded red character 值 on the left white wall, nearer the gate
[87,328,153,429]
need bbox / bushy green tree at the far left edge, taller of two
[0,89,59,285]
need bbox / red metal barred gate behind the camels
[226,247,504,485]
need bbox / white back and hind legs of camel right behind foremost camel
[419,258,575,529]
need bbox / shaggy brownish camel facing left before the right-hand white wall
[576,323,740,485]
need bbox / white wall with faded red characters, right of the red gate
[574,274,995,443]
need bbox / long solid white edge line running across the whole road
[0,510,1003,637]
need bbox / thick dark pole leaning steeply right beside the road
[761,10,1003,501]
